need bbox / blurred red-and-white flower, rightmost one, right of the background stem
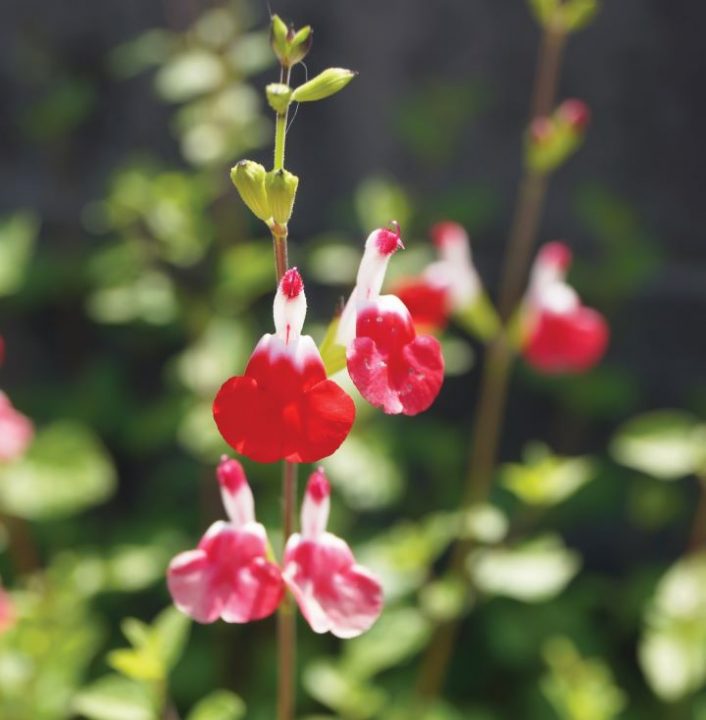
[522,242,609,374]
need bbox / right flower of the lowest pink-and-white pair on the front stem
[283,469,383,638]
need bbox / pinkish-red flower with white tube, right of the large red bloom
[338,227,444,415]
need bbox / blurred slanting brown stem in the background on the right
[417,22,566,701]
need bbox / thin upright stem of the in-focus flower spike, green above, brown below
[271,63,297,720]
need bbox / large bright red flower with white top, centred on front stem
[213,268,355,462]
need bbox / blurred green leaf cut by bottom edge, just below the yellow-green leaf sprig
[73,675,154,720]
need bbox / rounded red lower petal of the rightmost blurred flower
[523,307,609,373]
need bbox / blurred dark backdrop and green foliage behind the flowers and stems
[0,0,706,720]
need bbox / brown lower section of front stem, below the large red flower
[277,461,297,720]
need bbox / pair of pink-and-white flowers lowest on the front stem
[167,457,382,638]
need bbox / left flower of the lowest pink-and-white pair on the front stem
[167,456,284,623]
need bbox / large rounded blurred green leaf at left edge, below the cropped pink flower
[0,422,116,520]
